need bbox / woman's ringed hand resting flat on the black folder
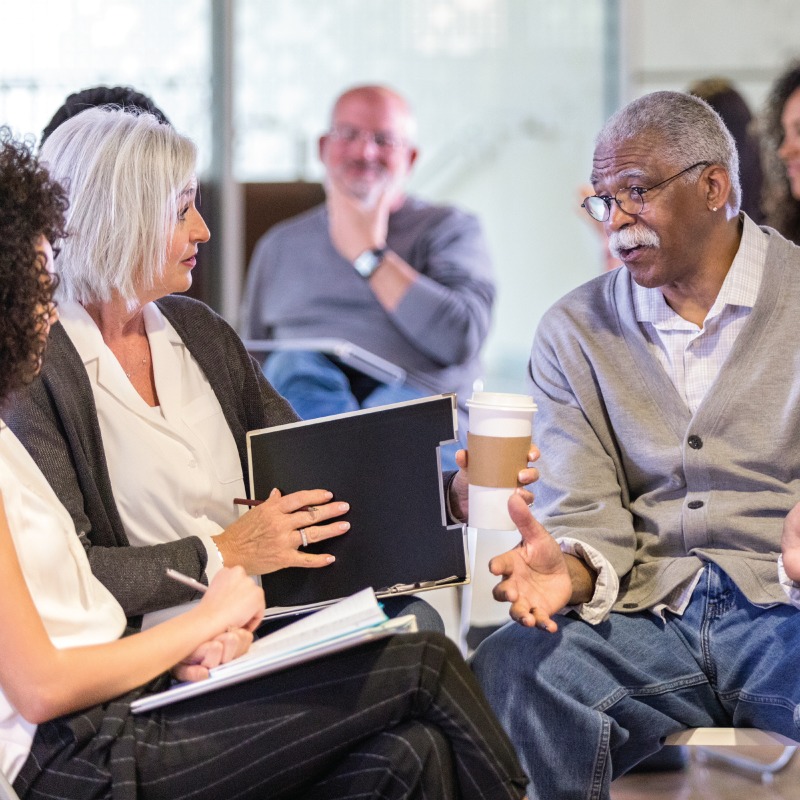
[214,489,350,575]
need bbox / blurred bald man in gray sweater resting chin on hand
[242,86,495,465]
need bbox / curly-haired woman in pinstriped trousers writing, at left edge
[0,125,525,800]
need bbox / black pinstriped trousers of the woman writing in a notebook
[14,633,527,800]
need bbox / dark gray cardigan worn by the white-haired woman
[4,295,297,617]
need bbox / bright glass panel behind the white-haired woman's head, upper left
[0,0,211,171]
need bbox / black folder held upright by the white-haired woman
[247,394,469,613]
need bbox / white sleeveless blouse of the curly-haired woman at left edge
[0,423,126,781]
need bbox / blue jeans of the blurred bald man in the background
[264,350,466,470]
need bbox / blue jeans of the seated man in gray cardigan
[472,564,800,800]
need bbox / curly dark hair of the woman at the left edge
[0,126,67,404]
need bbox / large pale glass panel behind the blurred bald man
[234,0,604,390]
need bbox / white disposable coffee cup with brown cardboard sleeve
[467,392,536,531]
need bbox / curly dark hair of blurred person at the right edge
[762,60,800,244]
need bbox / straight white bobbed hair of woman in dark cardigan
[40,106,197,309]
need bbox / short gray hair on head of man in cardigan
[595,92,742,213]
